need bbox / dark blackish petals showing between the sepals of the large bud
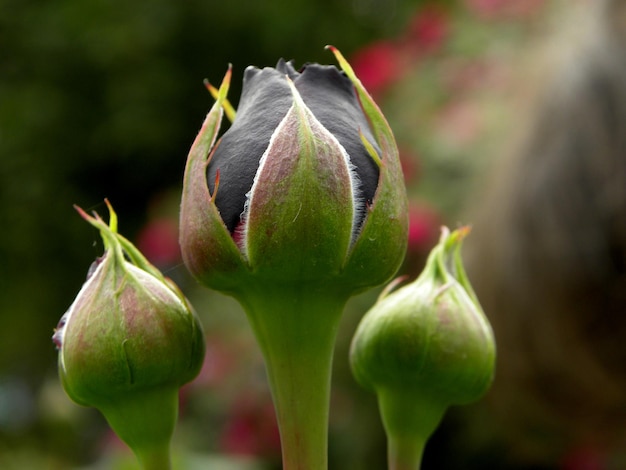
[207,59,380,233]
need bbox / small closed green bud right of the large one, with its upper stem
[350,228,495,466]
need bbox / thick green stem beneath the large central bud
[239,285,347,470]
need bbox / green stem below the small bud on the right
[377,389,446,470]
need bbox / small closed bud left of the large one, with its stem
[53,202,204,466]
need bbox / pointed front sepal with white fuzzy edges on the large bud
[244,80,355,282]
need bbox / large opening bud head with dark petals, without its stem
[181,49,407,291]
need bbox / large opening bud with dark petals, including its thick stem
[180,48,408,469]
